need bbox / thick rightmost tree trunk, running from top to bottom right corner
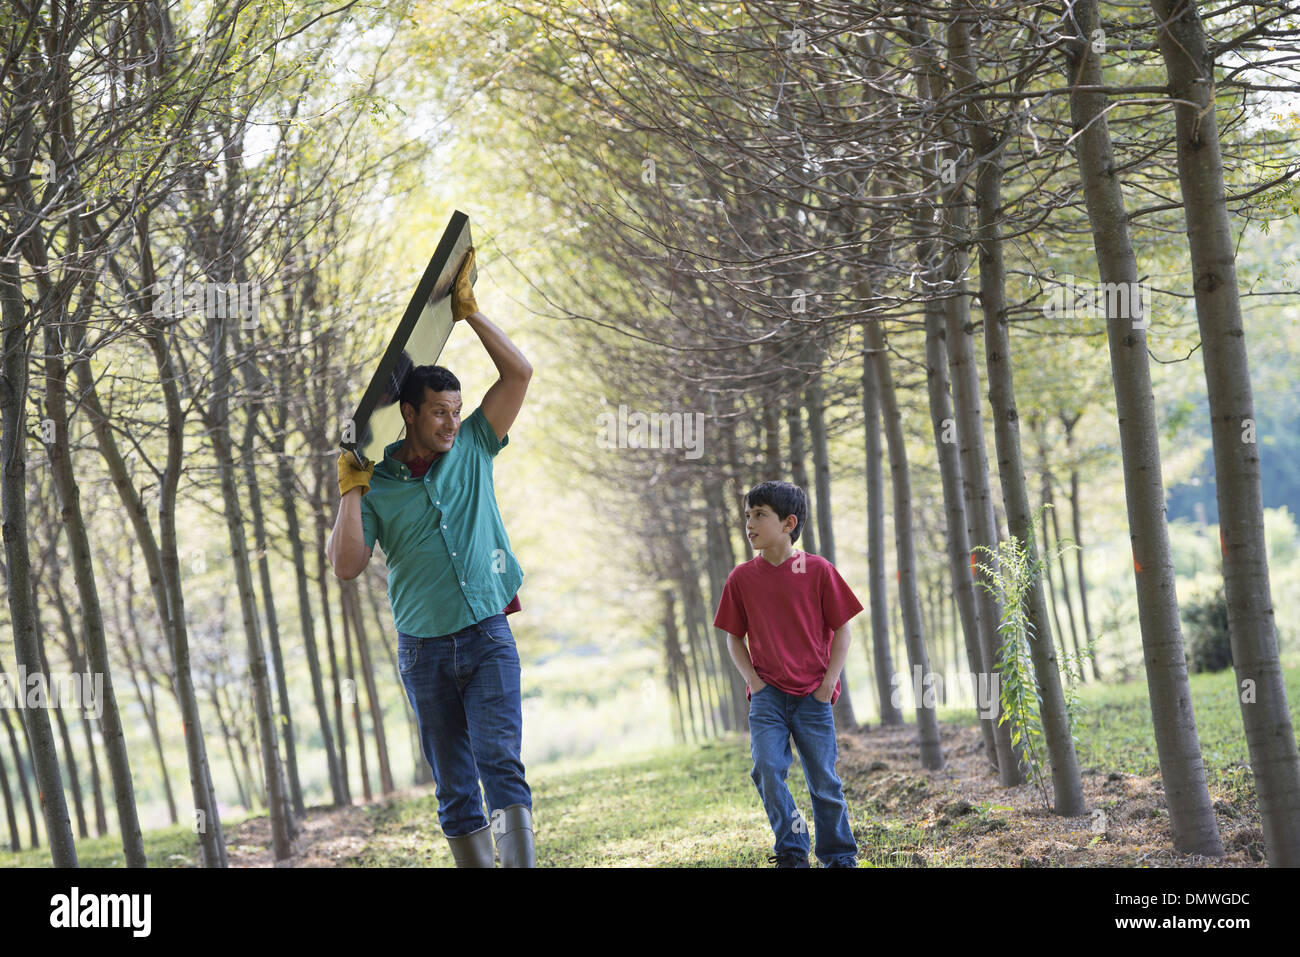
[1152,0,1300,867]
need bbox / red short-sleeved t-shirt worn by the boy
[714,551,862,703]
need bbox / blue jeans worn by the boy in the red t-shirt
[749,684,858,866]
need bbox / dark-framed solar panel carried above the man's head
[339,209,477,462]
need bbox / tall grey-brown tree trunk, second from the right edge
[1060,0,1223,857]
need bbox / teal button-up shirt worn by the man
[361,406,524,638]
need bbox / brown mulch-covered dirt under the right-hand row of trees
[839,726,1264,867]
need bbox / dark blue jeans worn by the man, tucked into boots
[398,614,533,837]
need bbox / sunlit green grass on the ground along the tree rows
[0,657,1300,867]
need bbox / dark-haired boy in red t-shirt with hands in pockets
[714,482,862,867]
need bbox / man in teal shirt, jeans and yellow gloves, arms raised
[326,250,536,867]
